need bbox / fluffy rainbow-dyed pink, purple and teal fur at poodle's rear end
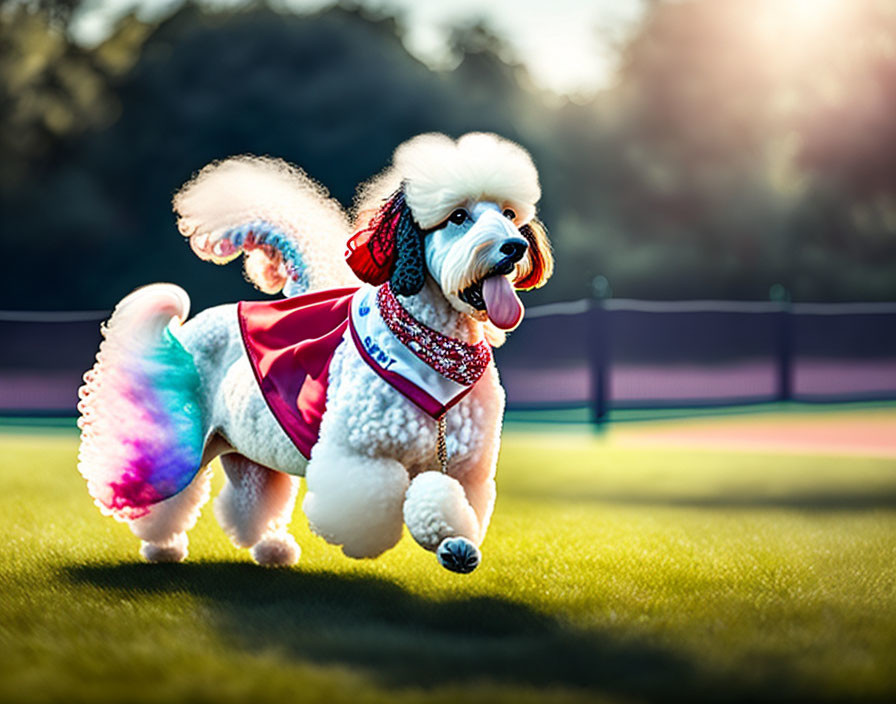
[78,284,203,520]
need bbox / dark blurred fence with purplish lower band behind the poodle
[0,299,896,420]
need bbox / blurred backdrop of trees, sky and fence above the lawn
[0,0,896,418]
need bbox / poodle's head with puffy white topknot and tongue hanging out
[348,133,554,338]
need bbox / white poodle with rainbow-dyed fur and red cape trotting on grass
[78,133,553,573]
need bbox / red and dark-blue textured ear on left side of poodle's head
[346,188,423,288]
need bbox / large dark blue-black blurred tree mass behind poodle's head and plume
[0,6,532,307]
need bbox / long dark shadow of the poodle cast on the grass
[66,562,800,701]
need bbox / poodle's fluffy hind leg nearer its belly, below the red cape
[215,453,301,565]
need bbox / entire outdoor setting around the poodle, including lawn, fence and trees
[0,9,896,704]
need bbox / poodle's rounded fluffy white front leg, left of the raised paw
[302,437,408,557]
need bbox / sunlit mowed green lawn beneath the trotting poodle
[0,410,896,704]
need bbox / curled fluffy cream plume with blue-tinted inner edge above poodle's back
[174,156,357,295]
